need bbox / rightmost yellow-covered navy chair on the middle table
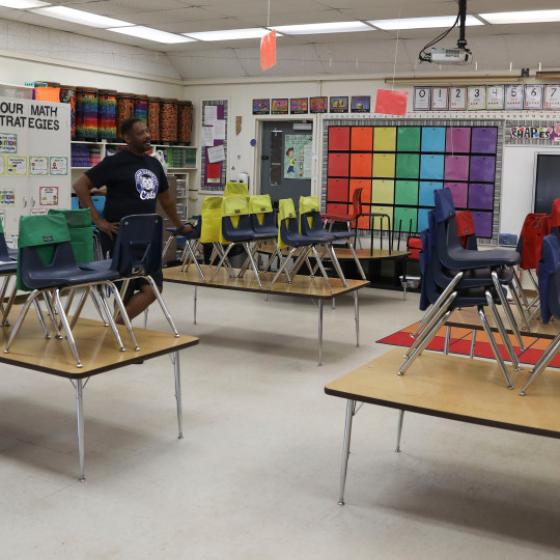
[299,196,366,285]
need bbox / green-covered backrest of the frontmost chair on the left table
[17,214,76,291]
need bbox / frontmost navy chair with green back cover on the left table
[4,210,137,367]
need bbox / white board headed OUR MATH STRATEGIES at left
[0,97,71,246]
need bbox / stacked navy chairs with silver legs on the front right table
[399,189,523,388]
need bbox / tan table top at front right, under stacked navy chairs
[325,349,560,438]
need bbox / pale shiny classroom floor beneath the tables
[0,285,560,560]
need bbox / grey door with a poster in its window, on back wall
[261,121,313,203]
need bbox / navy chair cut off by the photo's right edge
[519,234,560,396]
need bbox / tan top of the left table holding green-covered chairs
[0,309,199,379]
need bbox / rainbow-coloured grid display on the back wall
[326,123,499,238]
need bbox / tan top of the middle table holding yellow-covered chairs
[163,264,369,299]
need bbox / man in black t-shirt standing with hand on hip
[73,118,191,319]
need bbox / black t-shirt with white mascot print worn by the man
[86,150,169,222]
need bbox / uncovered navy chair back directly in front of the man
[111,214,163,277]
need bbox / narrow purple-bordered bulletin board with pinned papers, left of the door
[201,100,228,192]
